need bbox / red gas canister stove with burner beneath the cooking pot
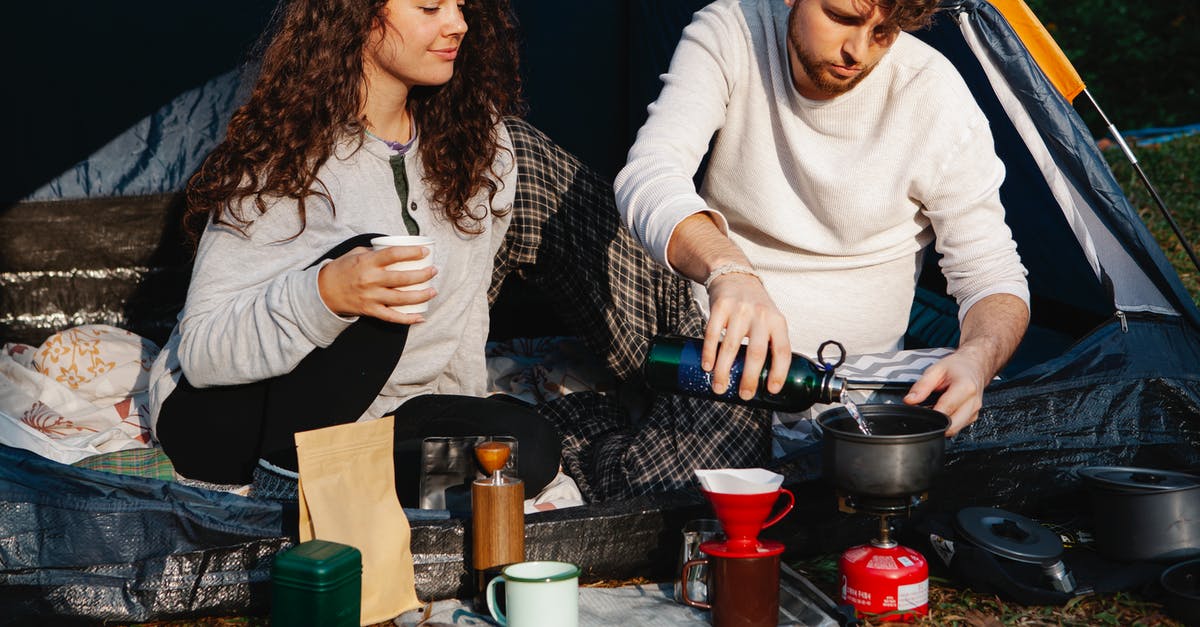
[838,494,929,622]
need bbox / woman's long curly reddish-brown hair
[184,0,522,245]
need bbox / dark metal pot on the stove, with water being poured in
[817,405,950,498]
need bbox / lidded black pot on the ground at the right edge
[1079,466,1200,561]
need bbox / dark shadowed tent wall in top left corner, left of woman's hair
[0,0,276,205]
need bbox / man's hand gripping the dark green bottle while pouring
[701,273,792,400]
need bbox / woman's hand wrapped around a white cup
[317,246,438,324]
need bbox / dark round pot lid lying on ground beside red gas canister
[955,507,1062,565]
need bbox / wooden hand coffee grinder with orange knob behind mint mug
[470,442,524,589]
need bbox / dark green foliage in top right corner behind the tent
[1027,0,1200,132]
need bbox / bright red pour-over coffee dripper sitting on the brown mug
[701,488,796,557]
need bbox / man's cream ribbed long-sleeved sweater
[616,0,1028,356]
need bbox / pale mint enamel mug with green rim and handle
[487,562,580,627]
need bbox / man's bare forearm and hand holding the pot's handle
[904,294,1030,437]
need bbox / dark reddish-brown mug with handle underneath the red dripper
[682,551,781,627]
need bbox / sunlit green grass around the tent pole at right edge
[1104,133,1200,305]
